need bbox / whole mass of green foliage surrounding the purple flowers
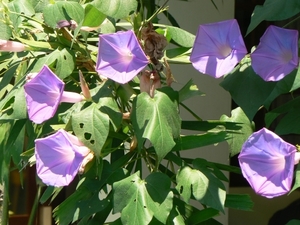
[0,0,300,225]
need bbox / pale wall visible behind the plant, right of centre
[162,0,234,225]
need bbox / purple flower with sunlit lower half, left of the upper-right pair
[190,19,247,78]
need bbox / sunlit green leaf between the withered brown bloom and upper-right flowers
[167,26,196,48]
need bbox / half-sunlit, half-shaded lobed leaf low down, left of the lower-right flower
[176,161,226,212]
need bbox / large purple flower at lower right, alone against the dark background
[239,128,297,198]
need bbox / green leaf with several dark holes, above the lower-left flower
[72,104,109,157]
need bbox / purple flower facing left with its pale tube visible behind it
[24,65,84,124]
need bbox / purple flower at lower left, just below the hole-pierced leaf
[35,129,90,187]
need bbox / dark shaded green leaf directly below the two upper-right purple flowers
[220,59,276,121]
